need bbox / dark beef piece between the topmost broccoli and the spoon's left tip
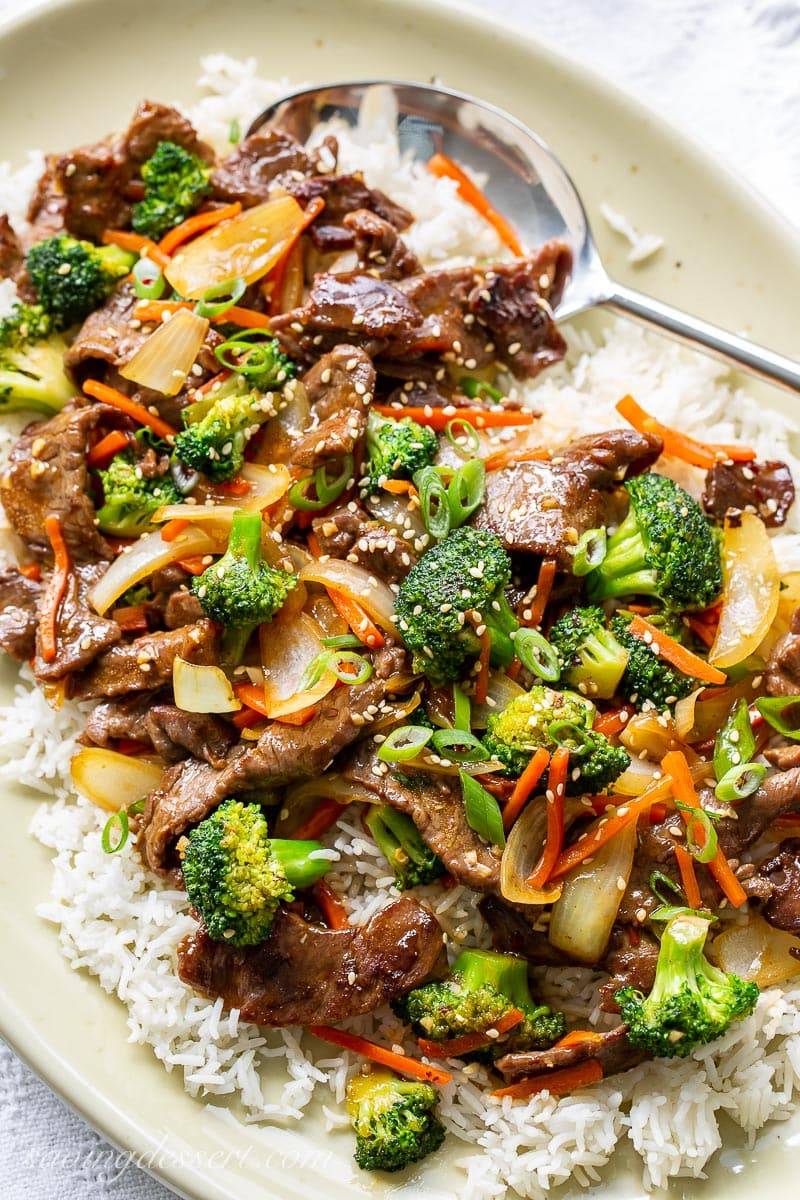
[211,130,314,209]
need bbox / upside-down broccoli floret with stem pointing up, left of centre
[192,509,297,664]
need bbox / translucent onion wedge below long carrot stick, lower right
[548,821,636,965]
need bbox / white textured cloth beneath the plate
[0,0,800,1200]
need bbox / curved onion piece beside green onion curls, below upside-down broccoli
[260,612,337,718]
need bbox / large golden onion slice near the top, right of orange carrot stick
[164,196,303,300]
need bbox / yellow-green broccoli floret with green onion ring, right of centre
[483,684,631,796]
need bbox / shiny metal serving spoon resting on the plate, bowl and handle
[248,79,800,391]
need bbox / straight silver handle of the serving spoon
[603,283,800,391]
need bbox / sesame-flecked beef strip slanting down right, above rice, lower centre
[342,743,500,892]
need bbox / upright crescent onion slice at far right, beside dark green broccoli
[709,512,781,668]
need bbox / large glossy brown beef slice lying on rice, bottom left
[178,896,446,1027]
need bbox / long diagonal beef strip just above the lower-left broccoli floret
[139,647,405,874]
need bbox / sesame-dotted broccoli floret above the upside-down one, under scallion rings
[175,369,291,484]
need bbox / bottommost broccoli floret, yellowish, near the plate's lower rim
[347,1070,445,1171]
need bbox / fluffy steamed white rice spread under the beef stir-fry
[0,54,800,1200]
